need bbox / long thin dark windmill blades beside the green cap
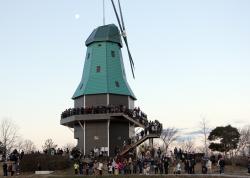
[111,0,135,78]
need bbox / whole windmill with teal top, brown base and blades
[61,0,160,156]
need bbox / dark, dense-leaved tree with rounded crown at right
[208,125,240,154]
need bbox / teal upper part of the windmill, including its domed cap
[72,24,136,100]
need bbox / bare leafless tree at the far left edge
[0,119,18,156]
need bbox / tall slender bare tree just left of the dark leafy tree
[200,117,210,155]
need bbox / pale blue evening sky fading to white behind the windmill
[0,0,250,148]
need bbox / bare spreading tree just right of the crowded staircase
[161,128,178,151]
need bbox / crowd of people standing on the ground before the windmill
[71,145,244,176]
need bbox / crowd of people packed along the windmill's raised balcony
[61,105,148,125]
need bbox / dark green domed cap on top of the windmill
[85,24,122,47]
